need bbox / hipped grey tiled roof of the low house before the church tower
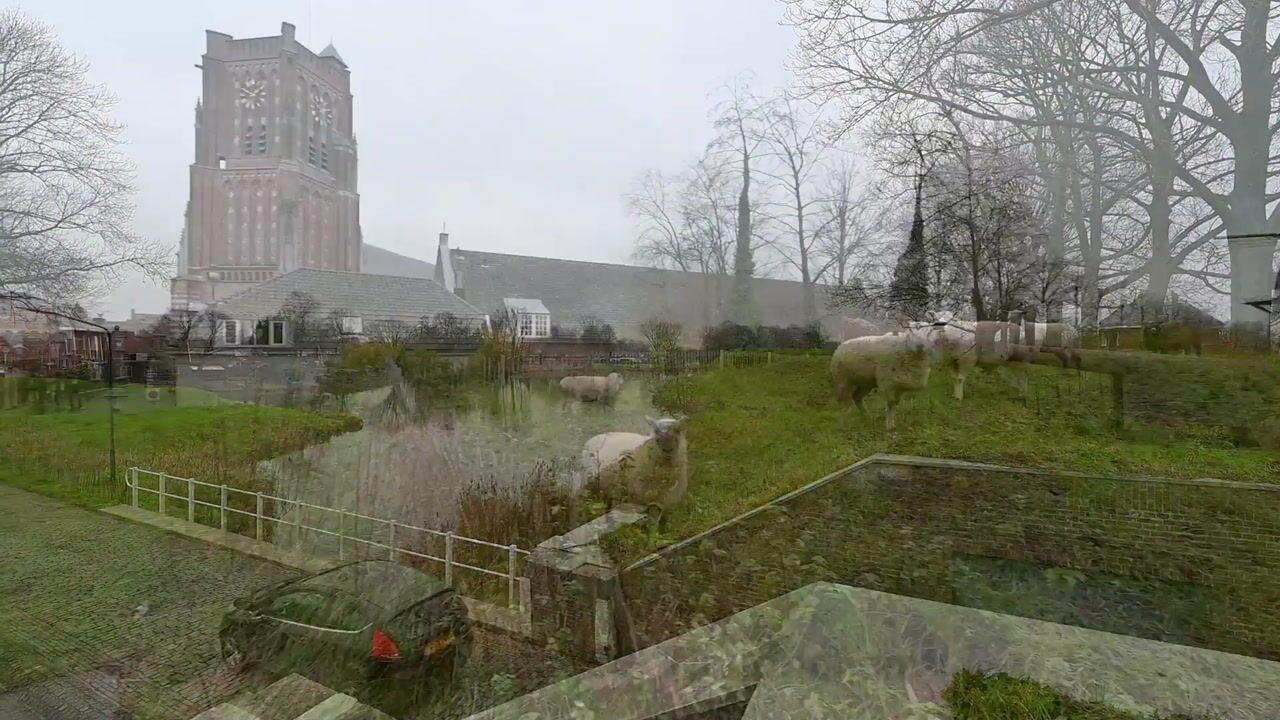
[218,268,484,323]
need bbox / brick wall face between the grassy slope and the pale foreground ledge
[622,456,1280,659]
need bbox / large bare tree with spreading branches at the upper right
[790,0,1280,323]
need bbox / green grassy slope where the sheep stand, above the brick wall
[609,357,1280,559]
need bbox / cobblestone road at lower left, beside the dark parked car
[0,487,294,719]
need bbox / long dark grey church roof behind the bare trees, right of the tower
[451,249,875,345]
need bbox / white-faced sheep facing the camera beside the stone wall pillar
[582,418,689,527]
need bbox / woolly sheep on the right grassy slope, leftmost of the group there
[831,329,931,430]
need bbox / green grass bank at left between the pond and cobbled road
[0,397,360,507]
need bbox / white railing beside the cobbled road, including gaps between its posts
[125,468,529,609]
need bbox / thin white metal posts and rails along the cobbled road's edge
[125,468,529,610]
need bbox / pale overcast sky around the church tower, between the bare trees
[23,0,792,319]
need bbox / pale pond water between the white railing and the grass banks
[260,377,660,550]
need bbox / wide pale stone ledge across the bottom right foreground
[470,583,1280,720]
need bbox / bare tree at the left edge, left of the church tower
[0,9,161,299]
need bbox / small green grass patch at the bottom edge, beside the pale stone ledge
[942,670,1189,720]
